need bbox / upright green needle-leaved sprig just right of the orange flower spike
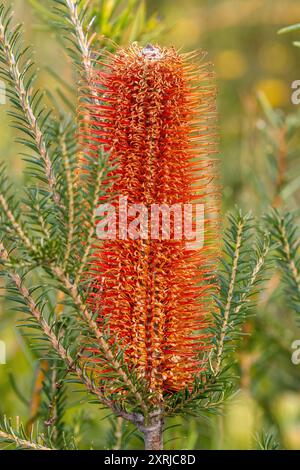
[210,210,270,375]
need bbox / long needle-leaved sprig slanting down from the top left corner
[0,2,60,205]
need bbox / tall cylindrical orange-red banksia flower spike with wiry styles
[80,45,219,400]
